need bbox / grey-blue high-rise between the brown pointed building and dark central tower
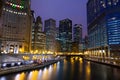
[44,18,56,52]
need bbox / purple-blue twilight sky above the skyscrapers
[31,0,87,36]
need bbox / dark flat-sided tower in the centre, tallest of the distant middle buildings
[59,18,72,52]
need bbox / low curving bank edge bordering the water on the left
[0,60,60,76]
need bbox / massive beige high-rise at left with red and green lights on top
[0,0,31,53]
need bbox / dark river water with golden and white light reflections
[0,58,120,80]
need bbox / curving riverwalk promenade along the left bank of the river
[0,59,60,76]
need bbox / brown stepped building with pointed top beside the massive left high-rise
[32,16,46,53]
